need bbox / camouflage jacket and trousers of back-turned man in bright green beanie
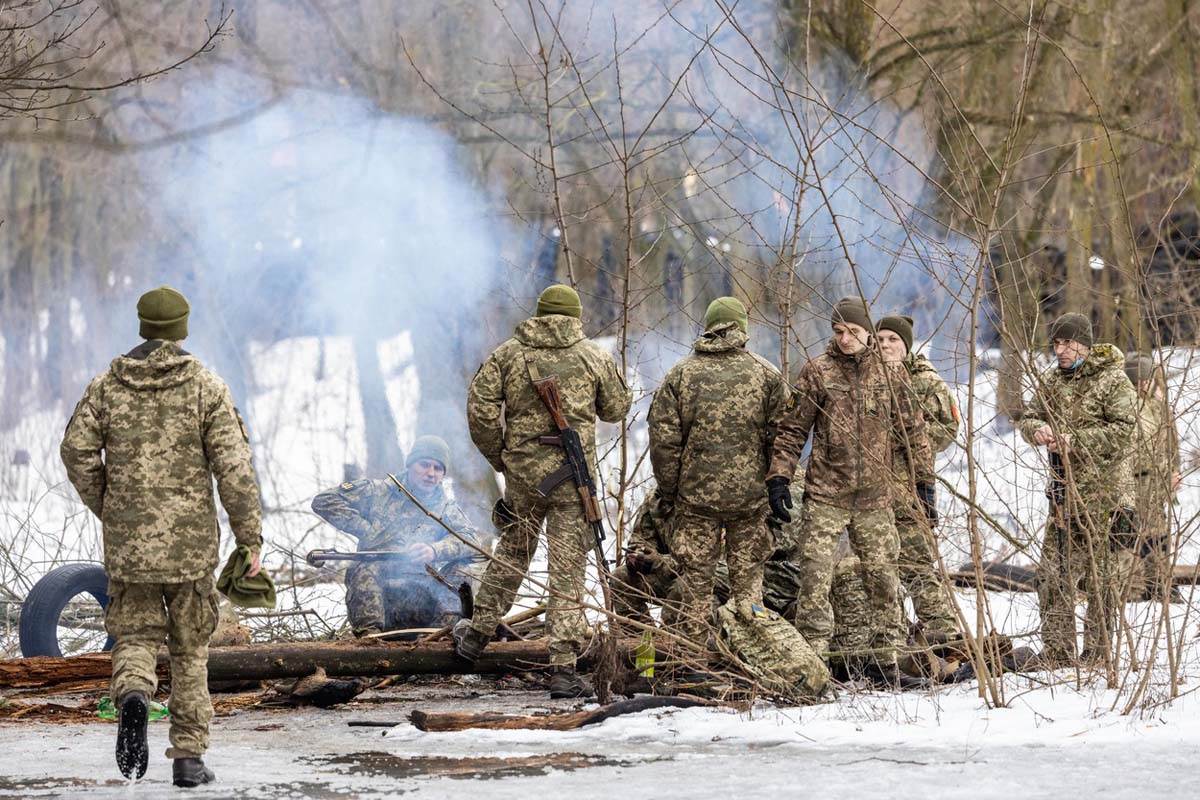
[648,323,790,644]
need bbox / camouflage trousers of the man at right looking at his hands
[1038,518,1134,662]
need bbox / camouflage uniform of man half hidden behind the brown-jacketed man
[892,354,959,633]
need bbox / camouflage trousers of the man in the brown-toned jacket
[796,500,904,664]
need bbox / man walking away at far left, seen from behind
[61,287,263,787]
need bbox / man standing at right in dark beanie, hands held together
[1018,314,1138,668]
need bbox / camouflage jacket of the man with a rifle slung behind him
[467,314,631,500]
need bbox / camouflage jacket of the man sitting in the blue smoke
[312,479,479,565]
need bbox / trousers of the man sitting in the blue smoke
[346,563,462,634]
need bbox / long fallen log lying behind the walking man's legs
[0,639,637,690]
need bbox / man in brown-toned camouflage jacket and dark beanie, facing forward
[767,297,932,686]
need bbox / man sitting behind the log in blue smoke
[312,437,479,637]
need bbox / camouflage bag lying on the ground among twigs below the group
[716,600,829,700]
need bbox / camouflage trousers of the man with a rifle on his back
[470,483,592,667]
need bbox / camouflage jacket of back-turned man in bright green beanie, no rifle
[649,323,791,515]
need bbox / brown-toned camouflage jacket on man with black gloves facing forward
[768,341,932,510]
